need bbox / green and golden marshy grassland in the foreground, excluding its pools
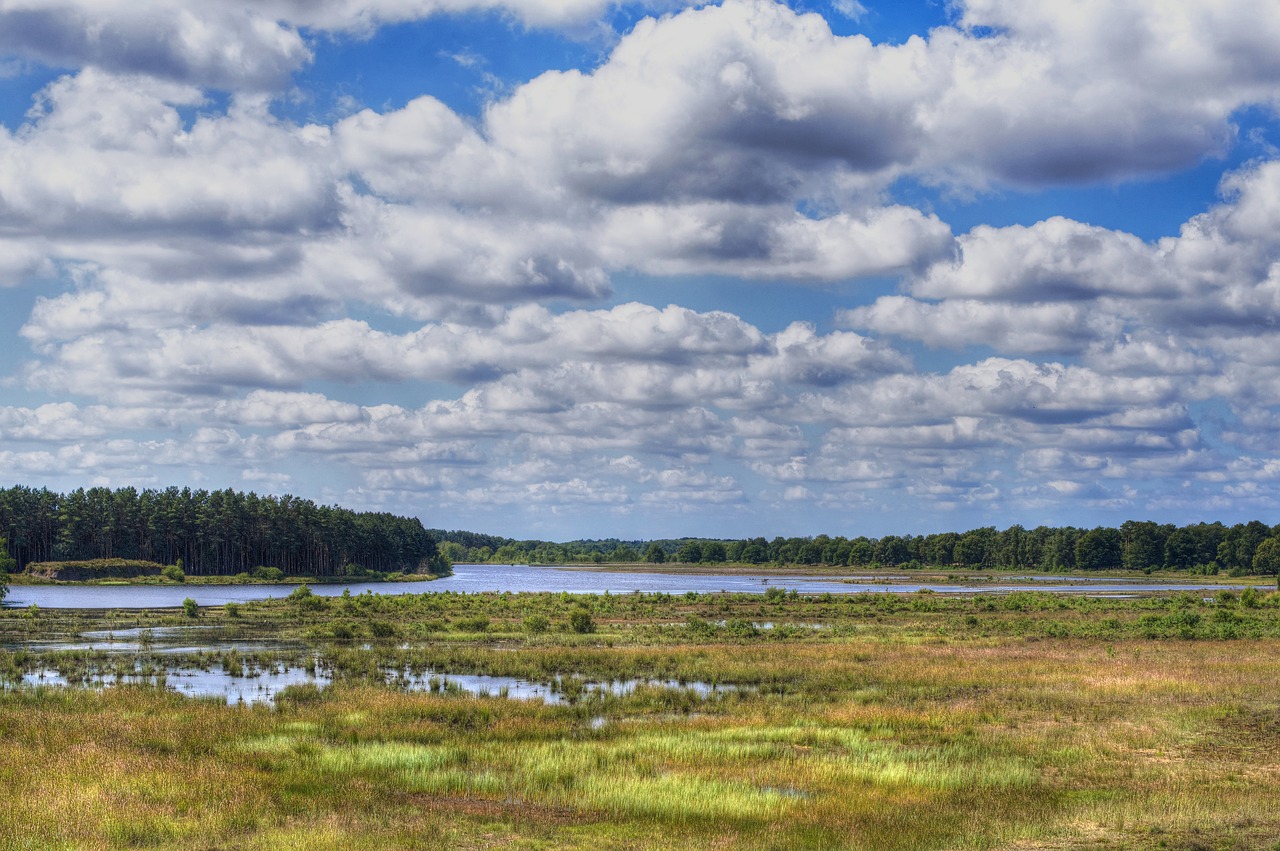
[0,589,1280,850]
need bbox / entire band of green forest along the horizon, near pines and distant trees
[0,486,1280,577]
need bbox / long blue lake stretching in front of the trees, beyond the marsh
[4,564,1221,609]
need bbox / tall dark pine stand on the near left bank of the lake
[0,486,447,576]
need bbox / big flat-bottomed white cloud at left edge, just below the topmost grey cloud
[0,69,337,239]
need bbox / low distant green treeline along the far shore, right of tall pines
[431,521,1280,576]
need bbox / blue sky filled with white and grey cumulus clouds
[0,0,1280,540]
